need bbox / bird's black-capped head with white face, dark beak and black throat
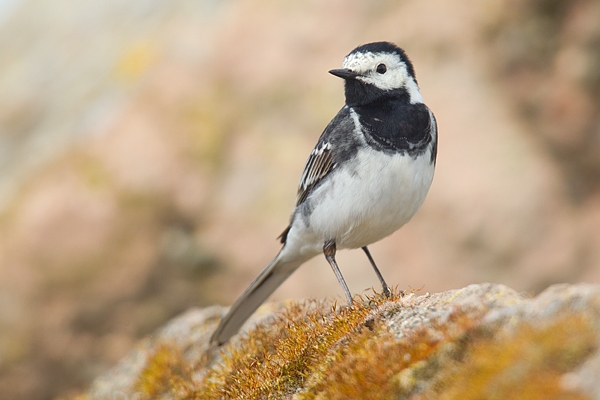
[329,42,423,106]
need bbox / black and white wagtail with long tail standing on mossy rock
[210,42,438,346]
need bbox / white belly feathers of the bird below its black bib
[307,147,434,249]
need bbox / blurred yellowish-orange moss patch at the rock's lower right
[426,314,596,400]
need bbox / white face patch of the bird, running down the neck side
[342,53,424,104]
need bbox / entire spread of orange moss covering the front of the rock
[131,294,596,400]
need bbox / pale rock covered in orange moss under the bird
[79,284,600,400]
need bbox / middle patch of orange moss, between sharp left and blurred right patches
[299,310,476,400]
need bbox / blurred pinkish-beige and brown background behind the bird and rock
[0,0,600,400]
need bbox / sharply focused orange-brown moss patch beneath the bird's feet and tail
[193,294,399,399]
